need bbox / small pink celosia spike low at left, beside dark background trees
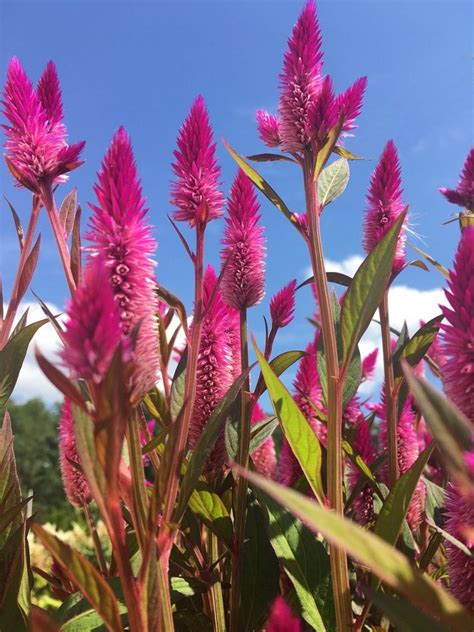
[58,399,91,507]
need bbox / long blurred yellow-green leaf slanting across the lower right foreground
[241,467,474,632]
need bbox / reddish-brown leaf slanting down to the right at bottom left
[32,523,123,632]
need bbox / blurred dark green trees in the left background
[8,399,77,529]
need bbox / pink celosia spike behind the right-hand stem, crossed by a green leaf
[380,395,426,530]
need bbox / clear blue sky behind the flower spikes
[0,0,474,402]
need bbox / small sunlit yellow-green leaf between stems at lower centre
[188,481,232,549]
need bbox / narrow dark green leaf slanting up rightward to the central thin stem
[173,369,250,522]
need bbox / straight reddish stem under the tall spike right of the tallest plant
[379,290,399,488]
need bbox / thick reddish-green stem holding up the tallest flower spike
[303,154,352,632]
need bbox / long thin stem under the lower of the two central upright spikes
[230,308,250,632]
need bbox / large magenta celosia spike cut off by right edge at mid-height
[440,227,474,423]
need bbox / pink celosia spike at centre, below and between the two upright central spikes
[189,266,233,472]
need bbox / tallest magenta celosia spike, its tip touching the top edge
[278,0,323,153]
